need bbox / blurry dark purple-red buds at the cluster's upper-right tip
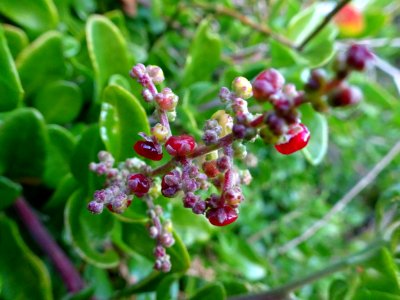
[304,45,374,112]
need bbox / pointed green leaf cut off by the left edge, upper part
[0,24,24,112]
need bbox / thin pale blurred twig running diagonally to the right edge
[278,142,400,254]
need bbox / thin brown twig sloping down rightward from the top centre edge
[186,3,294,48]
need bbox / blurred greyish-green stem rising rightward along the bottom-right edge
[230,240,387,300]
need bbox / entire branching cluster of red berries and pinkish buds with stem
[88,45,372,271]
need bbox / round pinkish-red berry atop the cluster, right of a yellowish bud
[253,69,285,102]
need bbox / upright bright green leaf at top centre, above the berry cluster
[182,20,222,86]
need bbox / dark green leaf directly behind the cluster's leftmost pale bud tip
[70,124,104,193]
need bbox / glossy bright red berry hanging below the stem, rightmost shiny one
[275,123,310,155]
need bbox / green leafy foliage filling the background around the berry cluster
[0,0,400,300]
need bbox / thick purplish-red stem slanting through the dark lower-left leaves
[14,197,84,293]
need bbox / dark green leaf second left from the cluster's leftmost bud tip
[43,125,75,188]
